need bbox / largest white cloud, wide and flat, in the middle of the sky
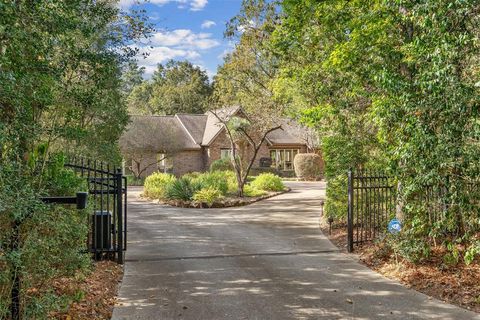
[151,29,220,50]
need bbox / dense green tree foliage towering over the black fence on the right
[272,0,480,258]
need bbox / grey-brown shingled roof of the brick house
[120,106,314,151]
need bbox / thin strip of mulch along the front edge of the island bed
[146,188,291,209]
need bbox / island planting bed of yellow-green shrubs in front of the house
[143,171,290,208]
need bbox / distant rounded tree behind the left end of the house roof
[128,60,212,115]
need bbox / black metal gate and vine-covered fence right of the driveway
[347,170,480,252]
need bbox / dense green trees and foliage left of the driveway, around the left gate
[0,0,148,319]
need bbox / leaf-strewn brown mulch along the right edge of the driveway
[322,226,480,312]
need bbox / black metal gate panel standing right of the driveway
[347,170,395,252]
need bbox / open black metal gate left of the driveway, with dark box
[65,156,127,264]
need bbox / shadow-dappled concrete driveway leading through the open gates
[113,183,480,320]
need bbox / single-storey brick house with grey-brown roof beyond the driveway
[120,107,315,177]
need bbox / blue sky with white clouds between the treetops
[120,0,241,78]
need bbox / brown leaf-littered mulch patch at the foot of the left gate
[49,261,123,320]
